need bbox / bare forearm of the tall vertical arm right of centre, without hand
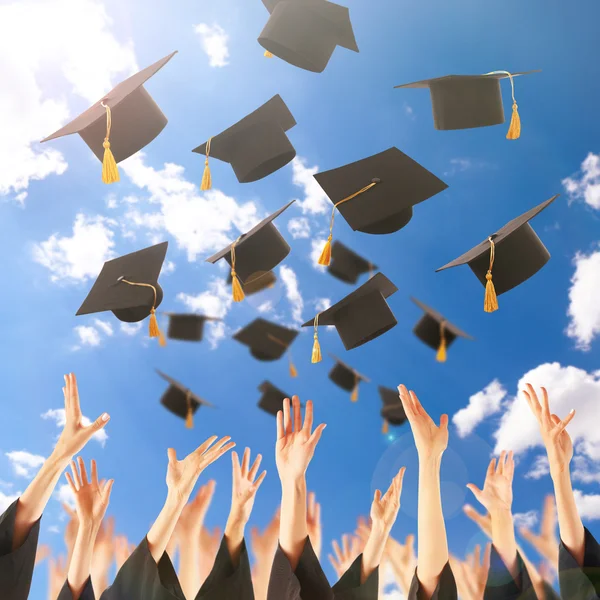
[417,456,448,598]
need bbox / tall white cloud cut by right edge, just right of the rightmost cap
[566,248,600,350]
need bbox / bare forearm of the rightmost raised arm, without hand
[551,467,585,566]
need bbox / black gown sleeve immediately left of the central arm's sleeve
[196,536,254,600]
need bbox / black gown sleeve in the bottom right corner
[558,527,600,600]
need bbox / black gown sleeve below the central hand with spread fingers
[267,536,334,600]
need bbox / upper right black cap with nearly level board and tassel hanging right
[396,71,540,140]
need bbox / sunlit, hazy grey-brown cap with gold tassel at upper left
[42,52,177,183]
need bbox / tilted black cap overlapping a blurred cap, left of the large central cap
[206,200,295,302]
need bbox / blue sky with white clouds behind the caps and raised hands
[0,0,600,600]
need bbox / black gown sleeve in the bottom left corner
[0,500,40,600]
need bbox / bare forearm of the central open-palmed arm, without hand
[279,476,308,570]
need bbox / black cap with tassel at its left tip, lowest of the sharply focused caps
[302,273,398,363]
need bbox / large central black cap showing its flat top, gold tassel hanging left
[314,147,448,265]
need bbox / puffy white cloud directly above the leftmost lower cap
[33,214,116,282]
